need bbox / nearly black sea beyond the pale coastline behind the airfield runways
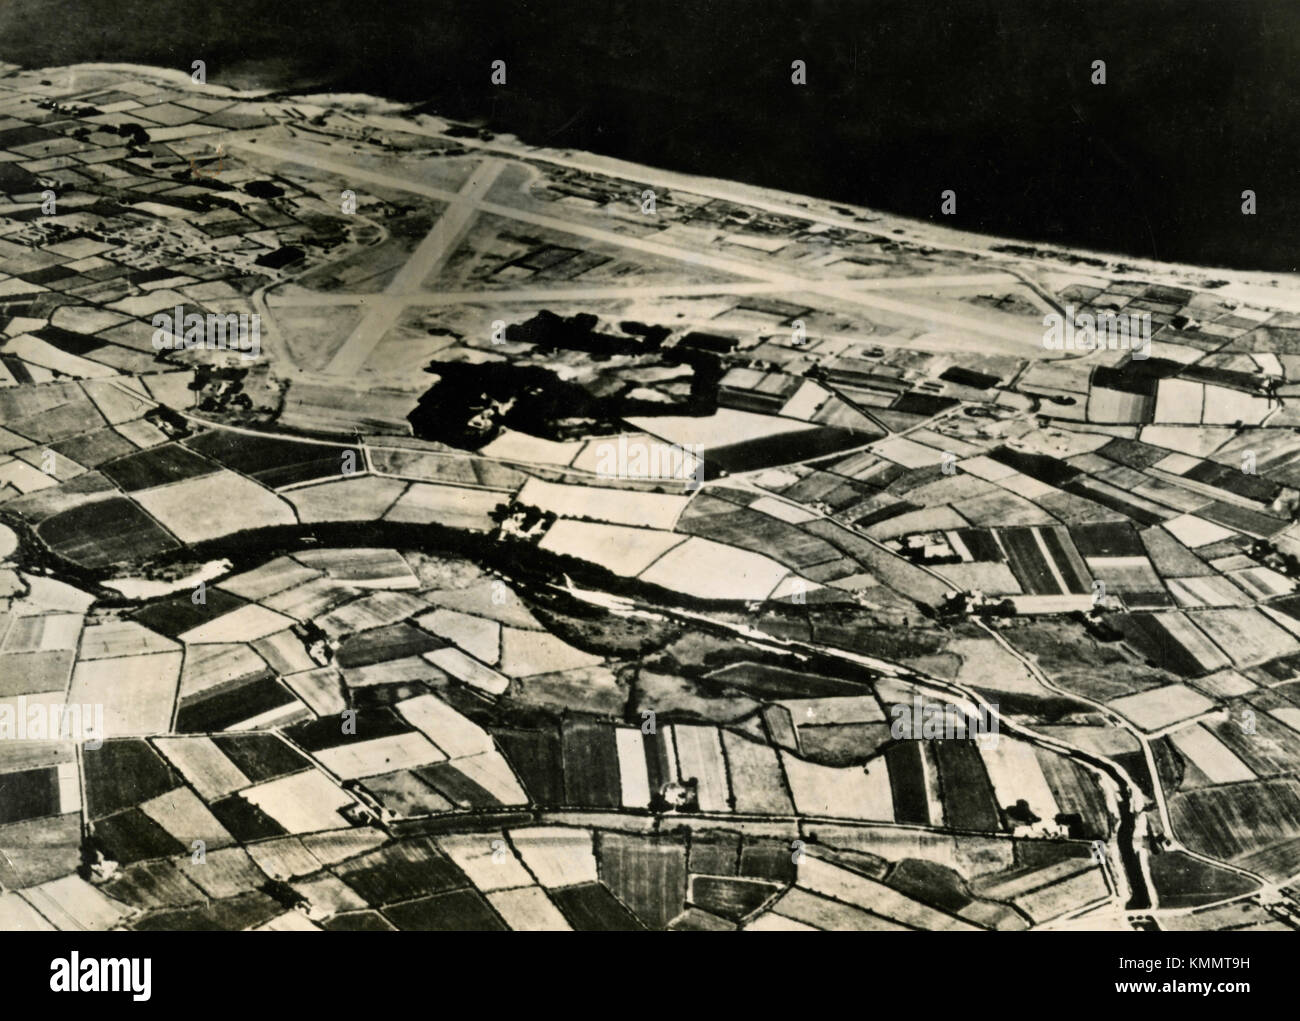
[0,0,1300,272]
